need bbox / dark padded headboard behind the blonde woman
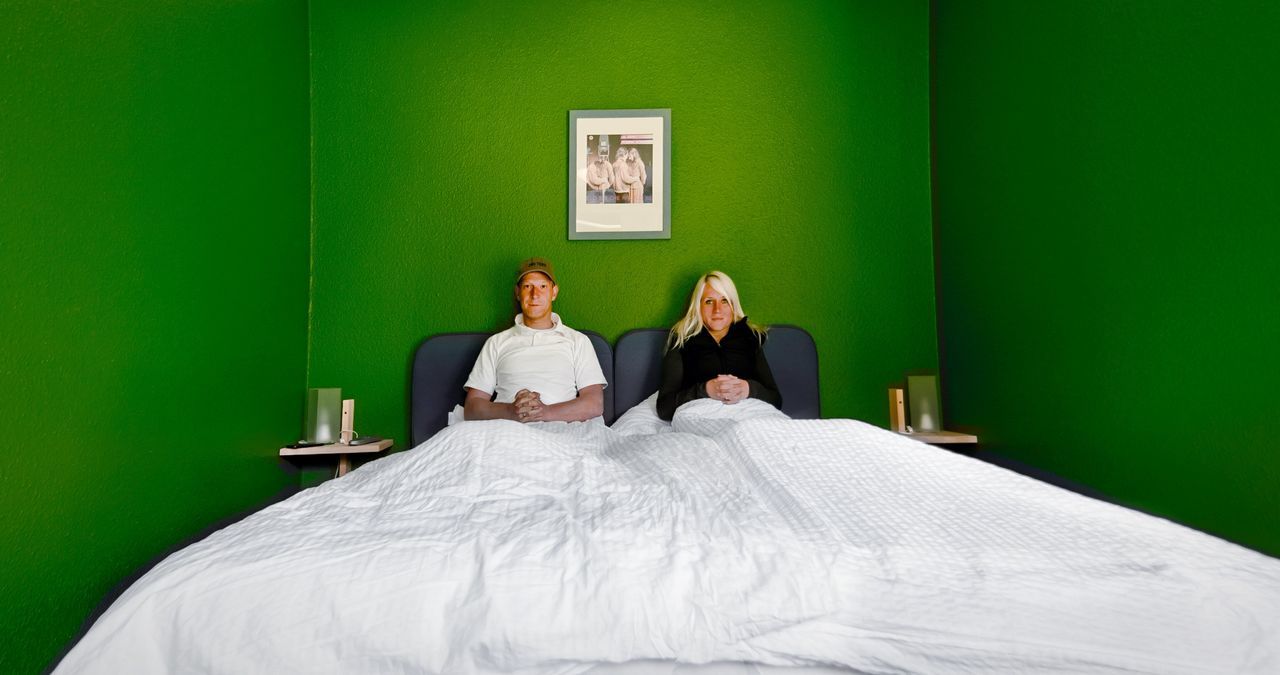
[611,325,822,419]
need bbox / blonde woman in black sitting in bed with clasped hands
[658,272,782,420]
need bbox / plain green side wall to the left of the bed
[0,0,308,672]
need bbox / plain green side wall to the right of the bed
[933,0,1280,555]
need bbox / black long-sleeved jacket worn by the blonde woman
[658,318,782,420]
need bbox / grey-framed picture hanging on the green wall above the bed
[568,109,671,240]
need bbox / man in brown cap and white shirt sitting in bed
[462,257,607,421]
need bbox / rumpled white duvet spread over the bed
[55,401,1280,675]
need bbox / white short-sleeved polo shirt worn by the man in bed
[465,313,608,405]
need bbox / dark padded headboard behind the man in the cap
[408,330,614,447]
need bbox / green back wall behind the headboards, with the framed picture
[308,0,937,447]
